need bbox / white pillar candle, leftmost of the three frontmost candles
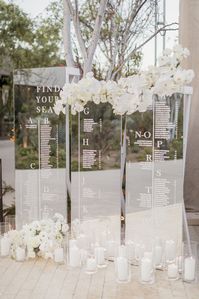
[115,256,131,283]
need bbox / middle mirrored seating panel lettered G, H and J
[71,103,121,245]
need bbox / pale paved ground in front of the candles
[0,227,199,299]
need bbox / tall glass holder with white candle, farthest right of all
[183,241,198,283]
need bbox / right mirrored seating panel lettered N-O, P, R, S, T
[125,93,189,250]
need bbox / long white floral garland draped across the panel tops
[54,45,194,115]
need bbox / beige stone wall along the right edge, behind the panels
[180,0,199,211]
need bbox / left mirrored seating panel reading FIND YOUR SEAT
[14,67,66,227]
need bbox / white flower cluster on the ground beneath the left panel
[7,213,69,258]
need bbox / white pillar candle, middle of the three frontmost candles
[140,257,155,284]
